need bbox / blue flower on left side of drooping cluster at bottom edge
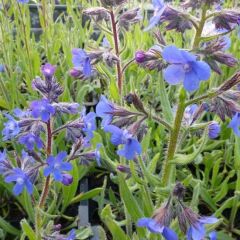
[137,218,178,240]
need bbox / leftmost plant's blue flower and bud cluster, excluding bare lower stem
[0,63,100,195]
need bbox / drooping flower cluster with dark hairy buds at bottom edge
[137,183,218,240]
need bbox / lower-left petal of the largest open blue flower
[164,65,185,85]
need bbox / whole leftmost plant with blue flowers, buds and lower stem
[0,63,101,239]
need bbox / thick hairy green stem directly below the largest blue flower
[162,89,186,186]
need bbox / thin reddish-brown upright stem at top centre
[110,10,123,95]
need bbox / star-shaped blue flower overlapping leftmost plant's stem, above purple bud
[43,152,72,182]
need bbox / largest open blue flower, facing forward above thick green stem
[162,46,211,92]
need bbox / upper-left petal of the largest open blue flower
[162,46,187,64]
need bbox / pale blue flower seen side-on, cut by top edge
[144,0,166,31]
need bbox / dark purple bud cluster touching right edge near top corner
[213,10,240,31]
